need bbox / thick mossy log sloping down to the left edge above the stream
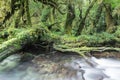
[0,26,47,61]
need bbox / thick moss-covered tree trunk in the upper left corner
[1,0,32,28]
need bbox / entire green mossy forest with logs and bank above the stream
[0,0,120,60]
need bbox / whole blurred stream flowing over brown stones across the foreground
[0,54,120,80]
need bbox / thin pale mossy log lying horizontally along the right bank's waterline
[54,45,120,58]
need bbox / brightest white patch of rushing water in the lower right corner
[92,58,120,80]
